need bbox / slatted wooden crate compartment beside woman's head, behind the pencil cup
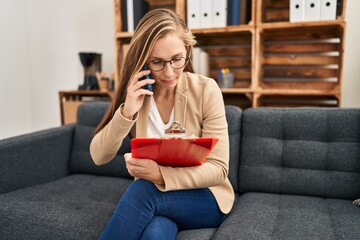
[195,30,254,88]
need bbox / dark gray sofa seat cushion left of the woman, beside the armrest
[0,174,132,240]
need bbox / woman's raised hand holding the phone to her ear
[122,70,155,119]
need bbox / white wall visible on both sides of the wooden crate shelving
[0,0,360,139]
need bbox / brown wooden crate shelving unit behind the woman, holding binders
[114,0,346,108]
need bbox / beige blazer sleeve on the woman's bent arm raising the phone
[90,104,139,165]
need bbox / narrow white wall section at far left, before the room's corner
[0,0,32,139]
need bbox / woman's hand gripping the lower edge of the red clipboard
[124,153,165,185]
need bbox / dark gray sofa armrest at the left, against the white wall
[0,125,75,193]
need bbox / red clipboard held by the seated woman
[131,138,218,167]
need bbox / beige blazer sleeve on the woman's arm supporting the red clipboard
[157,79,229,191]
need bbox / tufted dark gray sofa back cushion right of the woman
[239,108,360,199]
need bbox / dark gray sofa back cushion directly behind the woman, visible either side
[70,102,241,190]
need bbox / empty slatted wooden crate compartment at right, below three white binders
[257,24,344,91]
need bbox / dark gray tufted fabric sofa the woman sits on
[0,103,360,240]
